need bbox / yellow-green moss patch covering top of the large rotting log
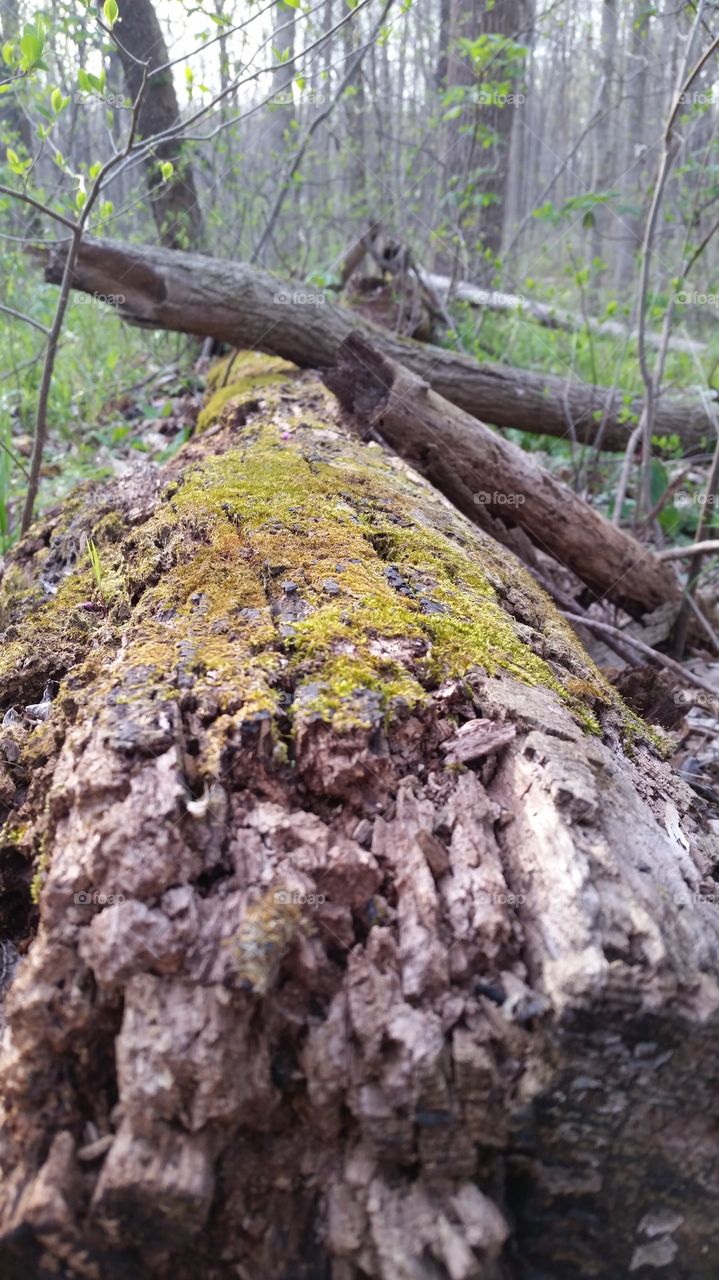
[107,394,610,747]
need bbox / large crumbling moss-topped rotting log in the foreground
[0,360,719,1280]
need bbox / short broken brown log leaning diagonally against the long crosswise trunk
[325,334,682,614]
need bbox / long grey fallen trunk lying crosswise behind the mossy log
[33,239,713,451]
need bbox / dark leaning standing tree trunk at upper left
[111,0,202,248]
